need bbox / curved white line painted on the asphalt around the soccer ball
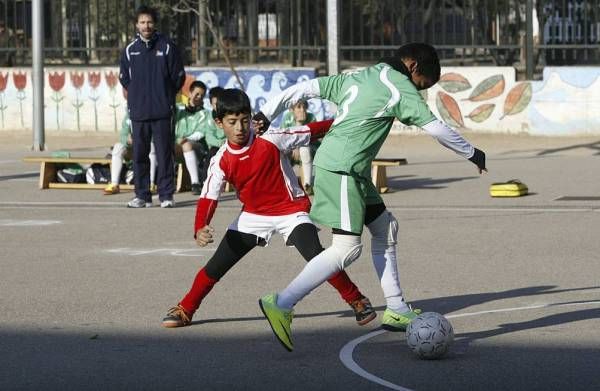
[339,300,600,391]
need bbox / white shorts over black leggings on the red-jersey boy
[229,212,314,244]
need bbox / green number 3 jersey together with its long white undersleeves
[260,63,474,178]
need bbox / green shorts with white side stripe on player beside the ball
[310,167,383,234]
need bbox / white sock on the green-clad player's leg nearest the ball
[367,211,409,313]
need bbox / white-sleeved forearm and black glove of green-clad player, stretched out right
[422,119,487,174]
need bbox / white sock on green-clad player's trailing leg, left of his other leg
[277,235,360,309]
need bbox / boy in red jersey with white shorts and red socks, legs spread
[162,89,376,327]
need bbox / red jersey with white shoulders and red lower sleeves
[194,121,332,233]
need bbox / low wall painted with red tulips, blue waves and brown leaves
[0,67,600,135]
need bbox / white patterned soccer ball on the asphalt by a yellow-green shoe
[406,312,454,360]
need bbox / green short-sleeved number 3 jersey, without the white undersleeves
[315,63,436,178]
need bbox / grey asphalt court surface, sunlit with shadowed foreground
[0,134,600,390]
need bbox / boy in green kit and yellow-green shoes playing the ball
[254,43,486,350]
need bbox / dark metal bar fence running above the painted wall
[0,0,600,75]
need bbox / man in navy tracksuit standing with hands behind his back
[119,6,185,208]
